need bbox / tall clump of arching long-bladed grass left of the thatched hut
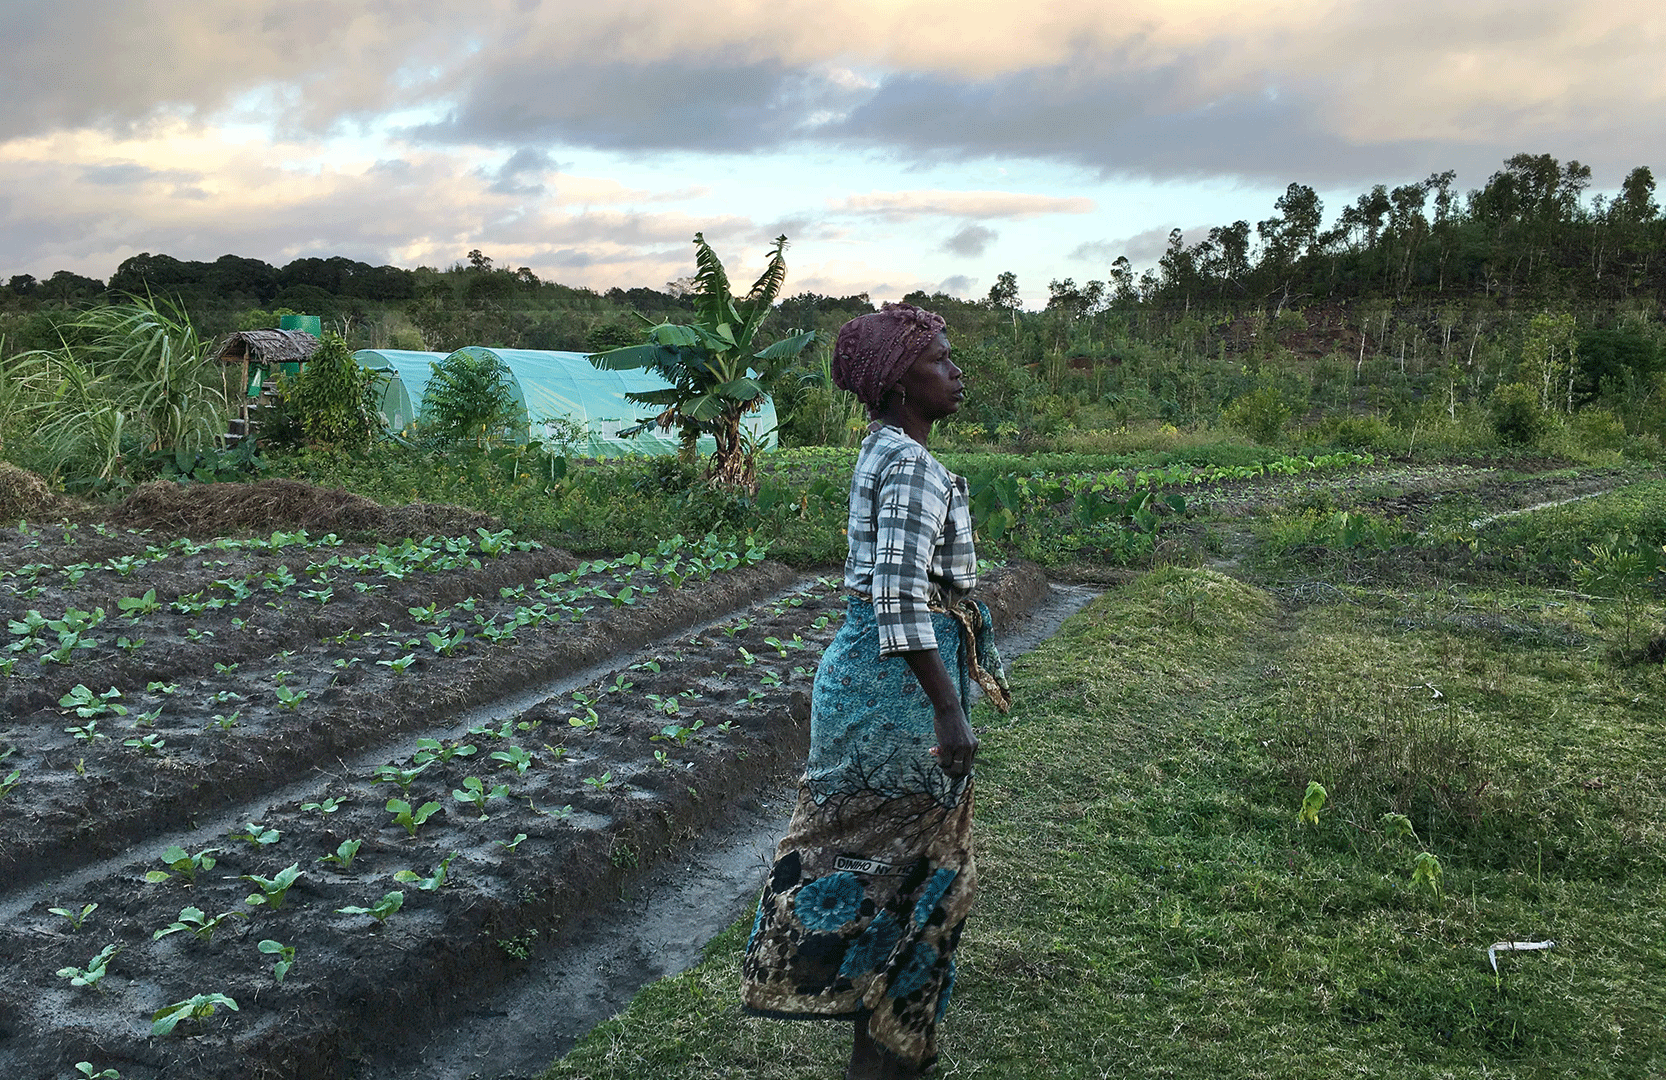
[0,297,228,490]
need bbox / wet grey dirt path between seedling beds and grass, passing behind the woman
[355,585,1100,1080]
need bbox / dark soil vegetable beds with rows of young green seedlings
[0,527,912,1078]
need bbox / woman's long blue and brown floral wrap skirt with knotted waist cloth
[741,598,1000,1067]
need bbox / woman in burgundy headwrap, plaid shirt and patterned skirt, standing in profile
[741,303,1006,1080]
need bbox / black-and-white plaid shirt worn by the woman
[845,423,978,657]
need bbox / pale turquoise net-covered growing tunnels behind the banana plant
[353,345,776,457]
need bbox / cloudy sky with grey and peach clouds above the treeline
[0,0,1666,305]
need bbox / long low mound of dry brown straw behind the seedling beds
[110,480,500,540]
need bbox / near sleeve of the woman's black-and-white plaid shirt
[873,455,948,657]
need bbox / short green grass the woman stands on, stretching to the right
[546,568,1666,1080]
